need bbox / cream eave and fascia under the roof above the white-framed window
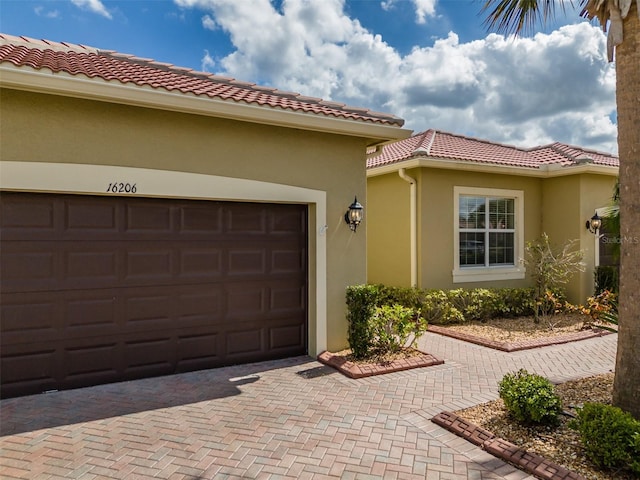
[367,156,619,178]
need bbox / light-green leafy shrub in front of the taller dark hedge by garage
[371,304,427,354]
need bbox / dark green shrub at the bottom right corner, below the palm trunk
[571,403,640,475]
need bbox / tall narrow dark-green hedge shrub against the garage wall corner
[347,285,379,358]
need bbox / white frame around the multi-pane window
[452,186,525,283]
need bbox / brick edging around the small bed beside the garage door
[318,351,444,378]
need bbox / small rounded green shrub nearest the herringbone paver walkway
[499,369,562,425]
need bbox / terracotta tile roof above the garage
[0,33,404,126]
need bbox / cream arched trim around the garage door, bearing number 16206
[0,161,327,356]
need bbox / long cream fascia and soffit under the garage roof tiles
[0,64,412,144]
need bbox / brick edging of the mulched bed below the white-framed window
[427,325,613,353]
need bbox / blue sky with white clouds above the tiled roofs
[0,0,616,152]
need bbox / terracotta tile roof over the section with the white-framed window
[367,130,619,169]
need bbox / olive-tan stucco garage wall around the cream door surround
[0,90,367,353]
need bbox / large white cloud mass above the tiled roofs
[175,0,617,151]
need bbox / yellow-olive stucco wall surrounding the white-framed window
[367,168,615,303]
